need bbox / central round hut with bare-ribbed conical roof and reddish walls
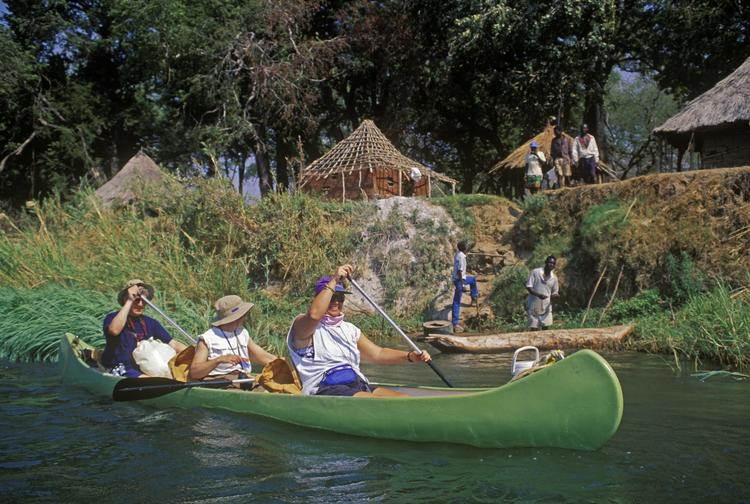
[299,119,458,201]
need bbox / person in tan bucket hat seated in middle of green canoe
[189,295,276,380]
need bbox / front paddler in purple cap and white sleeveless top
[287,264,431,397]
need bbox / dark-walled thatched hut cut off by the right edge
[654,58,750,168]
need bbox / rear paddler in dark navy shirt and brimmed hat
[101,279,185,378]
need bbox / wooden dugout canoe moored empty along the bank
[425,325,633,353]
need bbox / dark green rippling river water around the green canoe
[0,353,750,503]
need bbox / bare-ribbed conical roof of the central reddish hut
[300,119,458,187]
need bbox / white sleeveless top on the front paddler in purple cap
[286,321,367,395]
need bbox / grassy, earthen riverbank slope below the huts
[0,167,750,368]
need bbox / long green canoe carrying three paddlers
[60,334,623,450]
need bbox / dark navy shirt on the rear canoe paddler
[102,312,172,377]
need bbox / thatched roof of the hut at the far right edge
[654,58,750,136]
